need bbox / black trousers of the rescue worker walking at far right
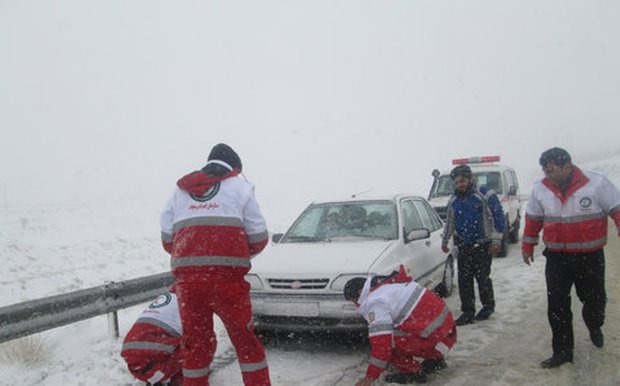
[543,249,607,354]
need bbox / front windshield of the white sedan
[281,200,398,243]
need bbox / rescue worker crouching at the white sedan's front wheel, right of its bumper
[344,266,456,386]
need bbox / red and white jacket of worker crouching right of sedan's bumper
[358,267,450,379]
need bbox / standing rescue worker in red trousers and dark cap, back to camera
[161,143,270,386]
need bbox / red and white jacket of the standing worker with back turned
[160,169,268,283]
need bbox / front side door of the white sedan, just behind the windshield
[400,198,441,288]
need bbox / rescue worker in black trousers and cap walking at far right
[522,147,620,368]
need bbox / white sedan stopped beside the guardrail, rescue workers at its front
[246,195,454,330]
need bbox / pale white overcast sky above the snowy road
[0,0,620,228]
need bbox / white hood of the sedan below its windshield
[250,240,395,277]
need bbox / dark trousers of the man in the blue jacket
[457,243,495,314]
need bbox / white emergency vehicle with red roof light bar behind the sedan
[428,156,521,257]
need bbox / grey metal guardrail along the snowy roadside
[0,272,174,343]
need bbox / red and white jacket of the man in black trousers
[522,166,620,253]
